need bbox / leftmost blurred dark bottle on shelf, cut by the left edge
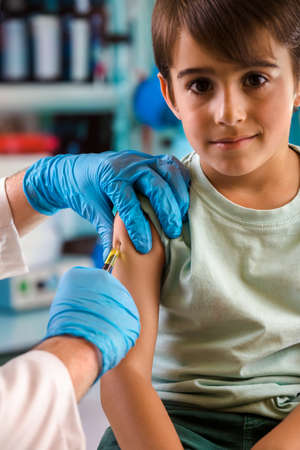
[1,0,30,82]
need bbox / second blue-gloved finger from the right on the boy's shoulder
[135,170,182,238]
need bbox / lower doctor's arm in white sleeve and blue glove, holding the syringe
[0,267,140,450]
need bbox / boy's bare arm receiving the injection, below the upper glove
[101,216,183,450]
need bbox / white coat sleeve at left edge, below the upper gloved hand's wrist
[0,178,28,279]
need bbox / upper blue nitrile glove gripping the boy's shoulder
[23,150,190,256]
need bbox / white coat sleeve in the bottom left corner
[0,350,86,450]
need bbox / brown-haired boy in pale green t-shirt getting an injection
[100,0,300,450]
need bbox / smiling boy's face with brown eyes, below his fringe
[160,26,300,176]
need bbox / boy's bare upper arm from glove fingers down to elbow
[113,215,164,377]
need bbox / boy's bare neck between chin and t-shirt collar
[204,150,300,210]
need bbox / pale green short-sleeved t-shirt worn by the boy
[145,145,300,419]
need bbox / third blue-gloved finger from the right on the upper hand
[102,180,152,253]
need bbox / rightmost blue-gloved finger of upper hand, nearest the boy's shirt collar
[156,155,190,218]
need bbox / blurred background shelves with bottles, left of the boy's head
[0,0,153,153]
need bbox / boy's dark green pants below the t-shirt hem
[98,402,279,450]
